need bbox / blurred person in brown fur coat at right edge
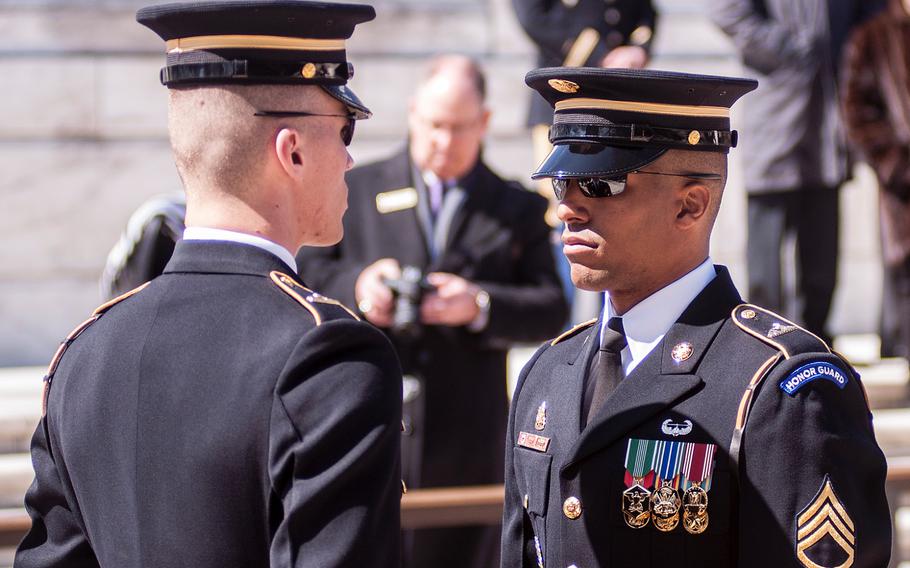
[842,0,910,359]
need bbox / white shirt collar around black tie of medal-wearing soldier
[601,257,717,375]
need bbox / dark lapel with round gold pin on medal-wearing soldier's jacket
[562,266,742,471]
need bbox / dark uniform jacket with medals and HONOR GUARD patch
[502,267,891,568]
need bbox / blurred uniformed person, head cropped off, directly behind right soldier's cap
[512,0,657,323]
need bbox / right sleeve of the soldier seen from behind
[269,320,401,568]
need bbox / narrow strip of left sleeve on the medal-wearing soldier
[501,345,547,568]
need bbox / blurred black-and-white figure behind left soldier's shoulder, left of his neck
[100,193,186,300]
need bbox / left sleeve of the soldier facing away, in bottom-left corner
[14,418,99,568]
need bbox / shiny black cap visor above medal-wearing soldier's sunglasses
[531,143,668,179]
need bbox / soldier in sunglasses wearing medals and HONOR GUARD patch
[502,68,891,568]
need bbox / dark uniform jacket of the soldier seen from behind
[15,241,401,568]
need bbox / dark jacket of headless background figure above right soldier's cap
[512,0,657,126]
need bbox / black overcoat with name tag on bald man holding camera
[298,151,566,486]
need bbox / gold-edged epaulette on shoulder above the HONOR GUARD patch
[733,304,831,359]
